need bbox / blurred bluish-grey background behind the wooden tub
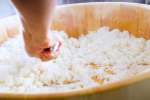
[0,0,150,18]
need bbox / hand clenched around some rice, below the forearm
[23,31,61,61]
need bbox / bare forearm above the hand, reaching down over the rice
[12,0,56,40]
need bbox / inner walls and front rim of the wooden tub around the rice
[0,3,150,98]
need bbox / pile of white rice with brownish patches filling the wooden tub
[0,27,150,92]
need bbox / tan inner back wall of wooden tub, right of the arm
[52,3,150,39]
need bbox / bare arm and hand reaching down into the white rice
[11,0,59,61]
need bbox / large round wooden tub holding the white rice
[0,2,150,100]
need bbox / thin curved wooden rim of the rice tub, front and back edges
[0,2,150,98]
